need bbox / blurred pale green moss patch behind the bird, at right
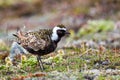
[77,20,114,37]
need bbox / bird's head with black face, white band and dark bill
[51,24,70,42]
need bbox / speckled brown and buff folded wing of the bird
[14,30,51,51]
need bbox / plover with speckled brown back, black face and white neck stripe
[13,24,70,71]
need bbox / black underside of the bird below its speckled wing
[25,43,57,56]
